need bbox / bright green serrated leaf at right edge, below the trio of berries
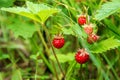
[90,37,120,53]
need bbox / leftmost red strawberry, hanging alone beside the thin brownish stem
[52,35,65,49]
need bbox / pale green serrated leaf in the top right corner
[95,1,120,21]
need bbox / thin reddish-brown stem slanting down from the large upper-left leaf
[42,24,65,78]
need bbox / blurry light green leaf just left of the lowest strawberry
[50,53,74,63]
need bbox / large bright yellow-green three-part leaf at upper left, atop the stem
[1,1,59,23]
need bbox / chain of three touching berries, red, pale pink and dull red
[78,15,99,44]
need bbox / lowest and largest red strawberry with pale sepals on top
[75,49,89,64]
